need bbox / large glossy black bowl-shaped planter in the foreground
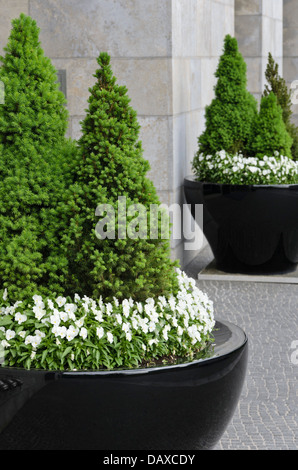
[0,322,248,450]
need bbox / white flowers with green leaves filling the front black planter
[0,269,215,370]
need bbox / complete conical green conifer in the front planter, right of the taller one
[64,52,177,300]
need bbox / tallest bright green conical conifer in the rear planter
[193,35,257,169]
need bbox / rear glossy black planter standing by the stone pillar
[184,177,298,274]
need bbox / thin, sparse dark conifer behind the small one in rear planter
[263,52,298,160]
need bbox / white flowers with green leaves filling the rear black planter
[197,150,298,184]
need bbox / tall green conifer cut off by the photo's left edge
[0,14,75,300]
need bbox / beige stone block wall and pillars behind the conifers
[0,0,298,264]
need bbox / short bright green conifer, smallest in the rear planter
[249,92,292,159]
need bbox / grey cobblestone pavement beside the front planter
[185,247,298,450]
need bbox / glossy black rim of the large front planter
[0,320,248,379]
